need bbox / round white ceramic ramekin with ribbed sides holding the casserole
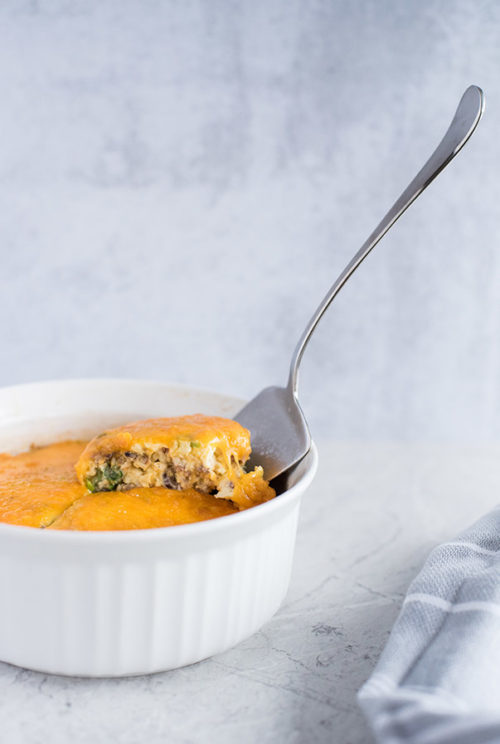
[0,380,317,677]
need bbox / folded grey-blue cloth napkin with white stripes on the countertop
[358,507,500,744]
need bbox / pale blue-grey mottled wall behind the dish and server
[0,0,500,440]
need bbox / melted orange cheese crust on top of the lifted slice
[76,414,251,483]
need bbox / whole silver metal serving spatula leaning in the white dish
[234,85,484,480]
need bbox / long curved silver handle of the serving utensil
[288,85,484,396]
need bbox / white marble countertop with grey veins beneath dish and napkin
[0,443,500,744]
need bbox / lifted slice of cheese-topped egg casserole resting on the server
[76,414,275,507]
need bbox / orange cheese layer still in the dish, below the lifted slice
[0,441,275,530]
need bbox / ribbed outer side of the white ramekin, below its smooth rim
[0,501,298,676]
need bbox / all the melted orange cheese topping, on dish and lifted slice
[0,416,275,530]
